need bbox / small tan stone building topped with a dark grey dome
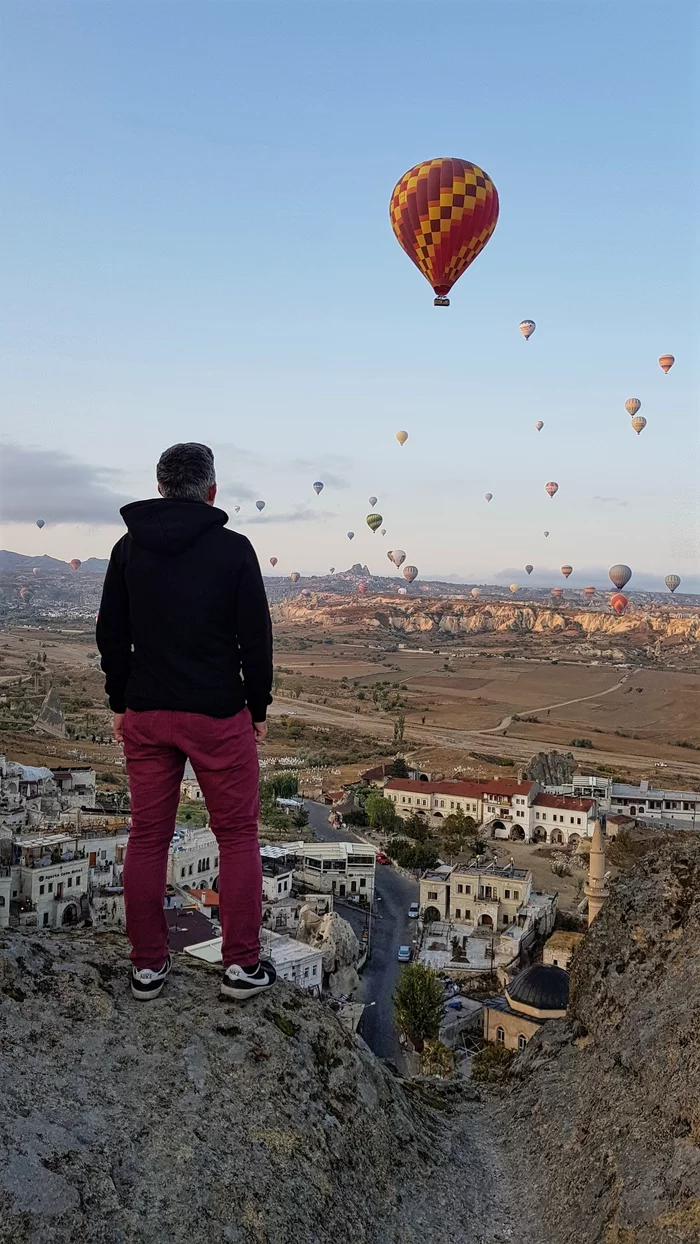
[482,963,568,1050]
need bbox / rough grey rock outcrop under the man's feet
[0,931,511,1244]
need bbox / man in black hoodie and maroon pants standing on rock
[97,443,275,999]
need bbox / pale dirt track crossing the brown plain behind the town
[270,687,700,784]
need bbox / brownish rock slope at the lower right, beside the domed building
[504,835,700,1244]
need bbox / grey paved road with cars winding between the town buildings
[306,800,418,1067]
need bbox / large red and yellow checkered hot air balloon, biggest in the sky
[389,159,499,306]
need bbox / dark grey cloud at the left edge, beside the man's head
[0,442,133,526]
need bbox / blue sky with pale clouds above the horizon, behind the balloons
[0,0,700,588]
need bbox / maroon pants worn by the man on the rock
[124,708,262,969]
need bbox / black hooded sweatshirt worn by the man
[97,500,272,722]
